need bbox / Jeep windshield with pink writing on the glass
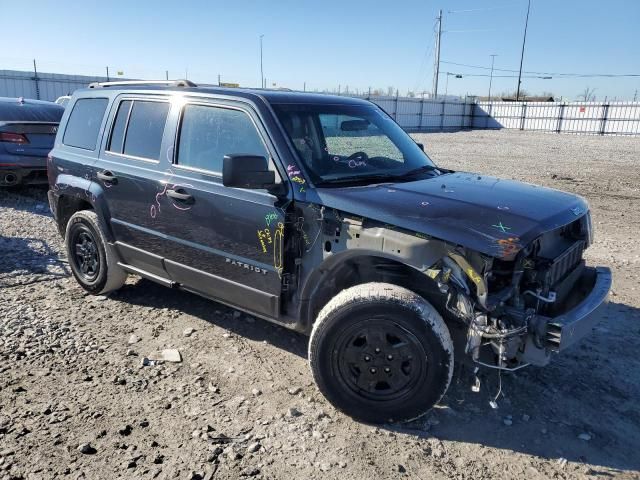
[273,104,439,185]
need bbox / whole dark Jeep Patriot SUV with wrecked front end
[48,81,611,422]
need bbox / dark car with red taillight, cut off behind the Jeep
[0,97,64,187]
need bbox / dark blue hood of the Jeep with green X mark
[316,172,588,259]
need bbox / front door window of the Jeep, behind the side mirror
[177,105,269,172]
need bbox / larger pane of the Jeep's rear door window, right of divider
[123,100,169,160]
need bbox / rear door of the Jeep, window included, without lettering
[93,95,172,278]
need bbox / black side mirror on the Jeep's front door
[222,154,276,189]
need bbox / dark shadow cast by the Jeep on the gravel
[111,280,640,475]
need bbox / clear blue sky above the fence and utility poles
[5,0,640,100]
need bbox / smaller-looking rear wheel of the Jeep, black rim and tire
[64,210,127,295]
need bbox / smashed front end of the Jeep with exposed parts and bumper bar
[427,213,612,370]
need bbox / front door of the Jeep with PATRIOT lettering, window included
[153,100,286,318]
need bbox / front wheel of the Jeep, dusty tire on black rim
[309,283,454,423]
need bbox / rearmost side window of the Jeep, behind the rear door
[62,98,109,150]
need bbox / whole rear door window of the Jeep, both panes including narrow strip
[107,100,169,160]
